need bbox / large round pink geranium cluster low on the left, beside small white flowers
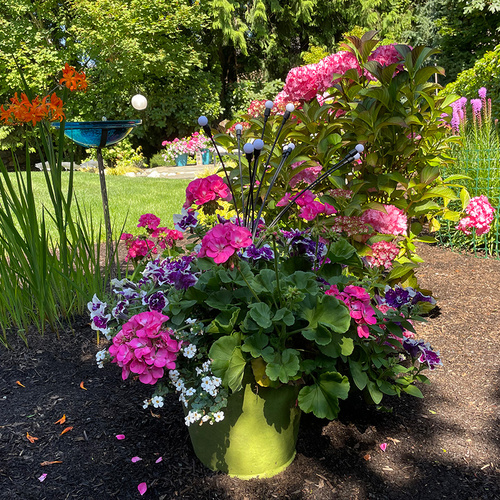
[109,311,182,385]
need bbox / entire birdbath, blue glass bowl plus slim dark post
[52,120,142,273]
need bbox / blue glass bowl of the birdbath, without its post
[52,120,142,148]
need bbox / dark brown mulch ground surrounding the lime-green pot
[0,246,500,500]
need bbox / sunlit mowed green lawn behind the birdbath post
[17,172,190,240]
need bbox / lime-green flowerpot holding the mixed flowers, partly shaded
[189,382,300,479]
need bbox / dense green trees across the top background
[0,0,500,157]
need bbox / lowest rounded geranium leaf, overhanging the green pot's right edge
[298,372,350,420]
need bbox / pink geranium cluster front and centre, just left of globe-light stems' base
[198,222,252,264]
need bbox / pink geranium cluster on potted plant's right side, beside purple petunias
[325,285,377,338]
